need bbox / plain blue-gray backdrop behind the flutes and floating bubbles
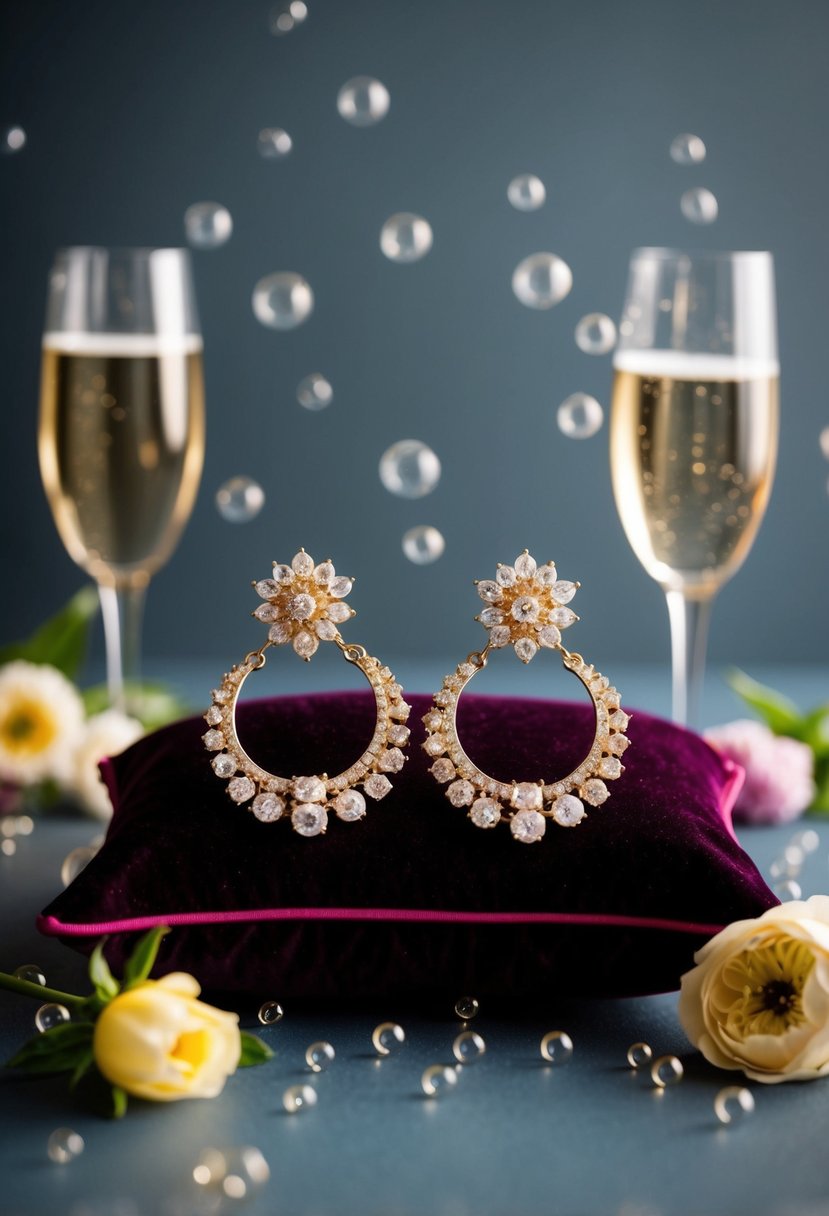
[0,0,829,685]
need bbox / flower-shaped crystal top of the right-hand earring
[475,550,581,663]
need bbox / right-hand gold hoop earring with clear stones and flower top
[423,550,630,844]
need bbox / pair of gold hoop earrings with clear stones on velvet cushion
[203,550,630,844]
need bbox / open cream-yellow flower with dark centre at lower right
[679,895,829,1083]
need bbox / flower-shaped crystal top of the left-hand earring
[252,548,356,662]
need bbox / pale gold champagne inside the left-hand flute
[38,334,204,585]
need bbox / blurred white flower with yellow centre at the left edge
[0,659,84,786]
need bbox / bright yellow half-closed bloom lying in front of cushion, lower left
[92,972,242,1102]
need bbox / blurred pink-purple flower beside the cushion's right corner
[705,719,814,823]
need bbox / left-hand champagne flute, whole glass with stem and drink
[38,247,204,710]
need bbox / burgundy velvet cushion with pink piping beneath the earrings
[39,693,777,1001]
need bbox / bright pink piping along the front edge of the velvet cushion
[36,908,723,938]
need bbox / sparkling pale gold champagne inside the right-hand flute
[610,350,779,598]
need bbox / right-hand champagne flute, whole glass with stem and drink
[610,248,779,725]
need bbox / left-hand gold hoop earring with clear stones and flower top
[202,548,411,837]
